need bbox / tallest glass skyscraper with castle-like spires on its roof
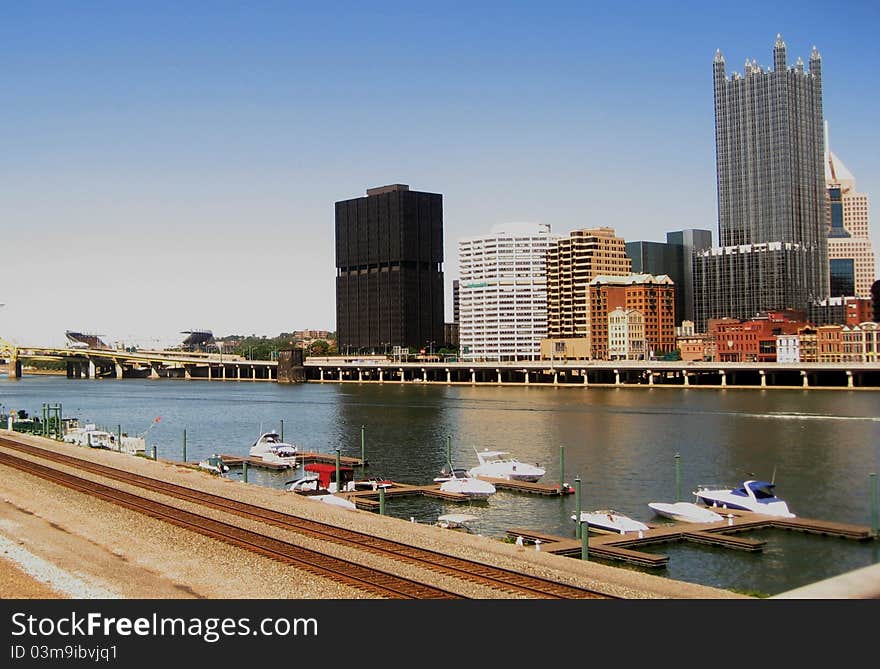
[694,35,829,330]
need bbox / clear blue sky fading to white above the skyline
[0,2,880,345]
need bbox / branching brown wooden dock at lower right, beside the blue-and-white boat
[506,509,874,568]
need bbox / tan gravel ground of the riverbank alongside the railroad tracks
[0,431,744,599]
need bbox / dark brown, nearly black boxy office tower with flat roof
[336,184,444,354]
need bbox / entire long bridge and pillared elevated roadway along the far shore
[0,339,880,390]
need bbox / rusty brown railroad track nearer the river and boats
[0,437,616,599]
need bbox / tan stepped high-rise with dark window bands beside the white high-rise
[547,228,632,339]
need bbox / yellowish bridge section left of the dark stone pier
[0,339,278,381]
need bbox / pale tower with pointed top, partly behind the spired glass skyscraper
[825,123,877,297]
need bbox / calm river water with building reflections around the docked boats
[0,376,880,595]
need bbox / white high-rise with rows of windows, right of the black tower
[458,223,558,360]
